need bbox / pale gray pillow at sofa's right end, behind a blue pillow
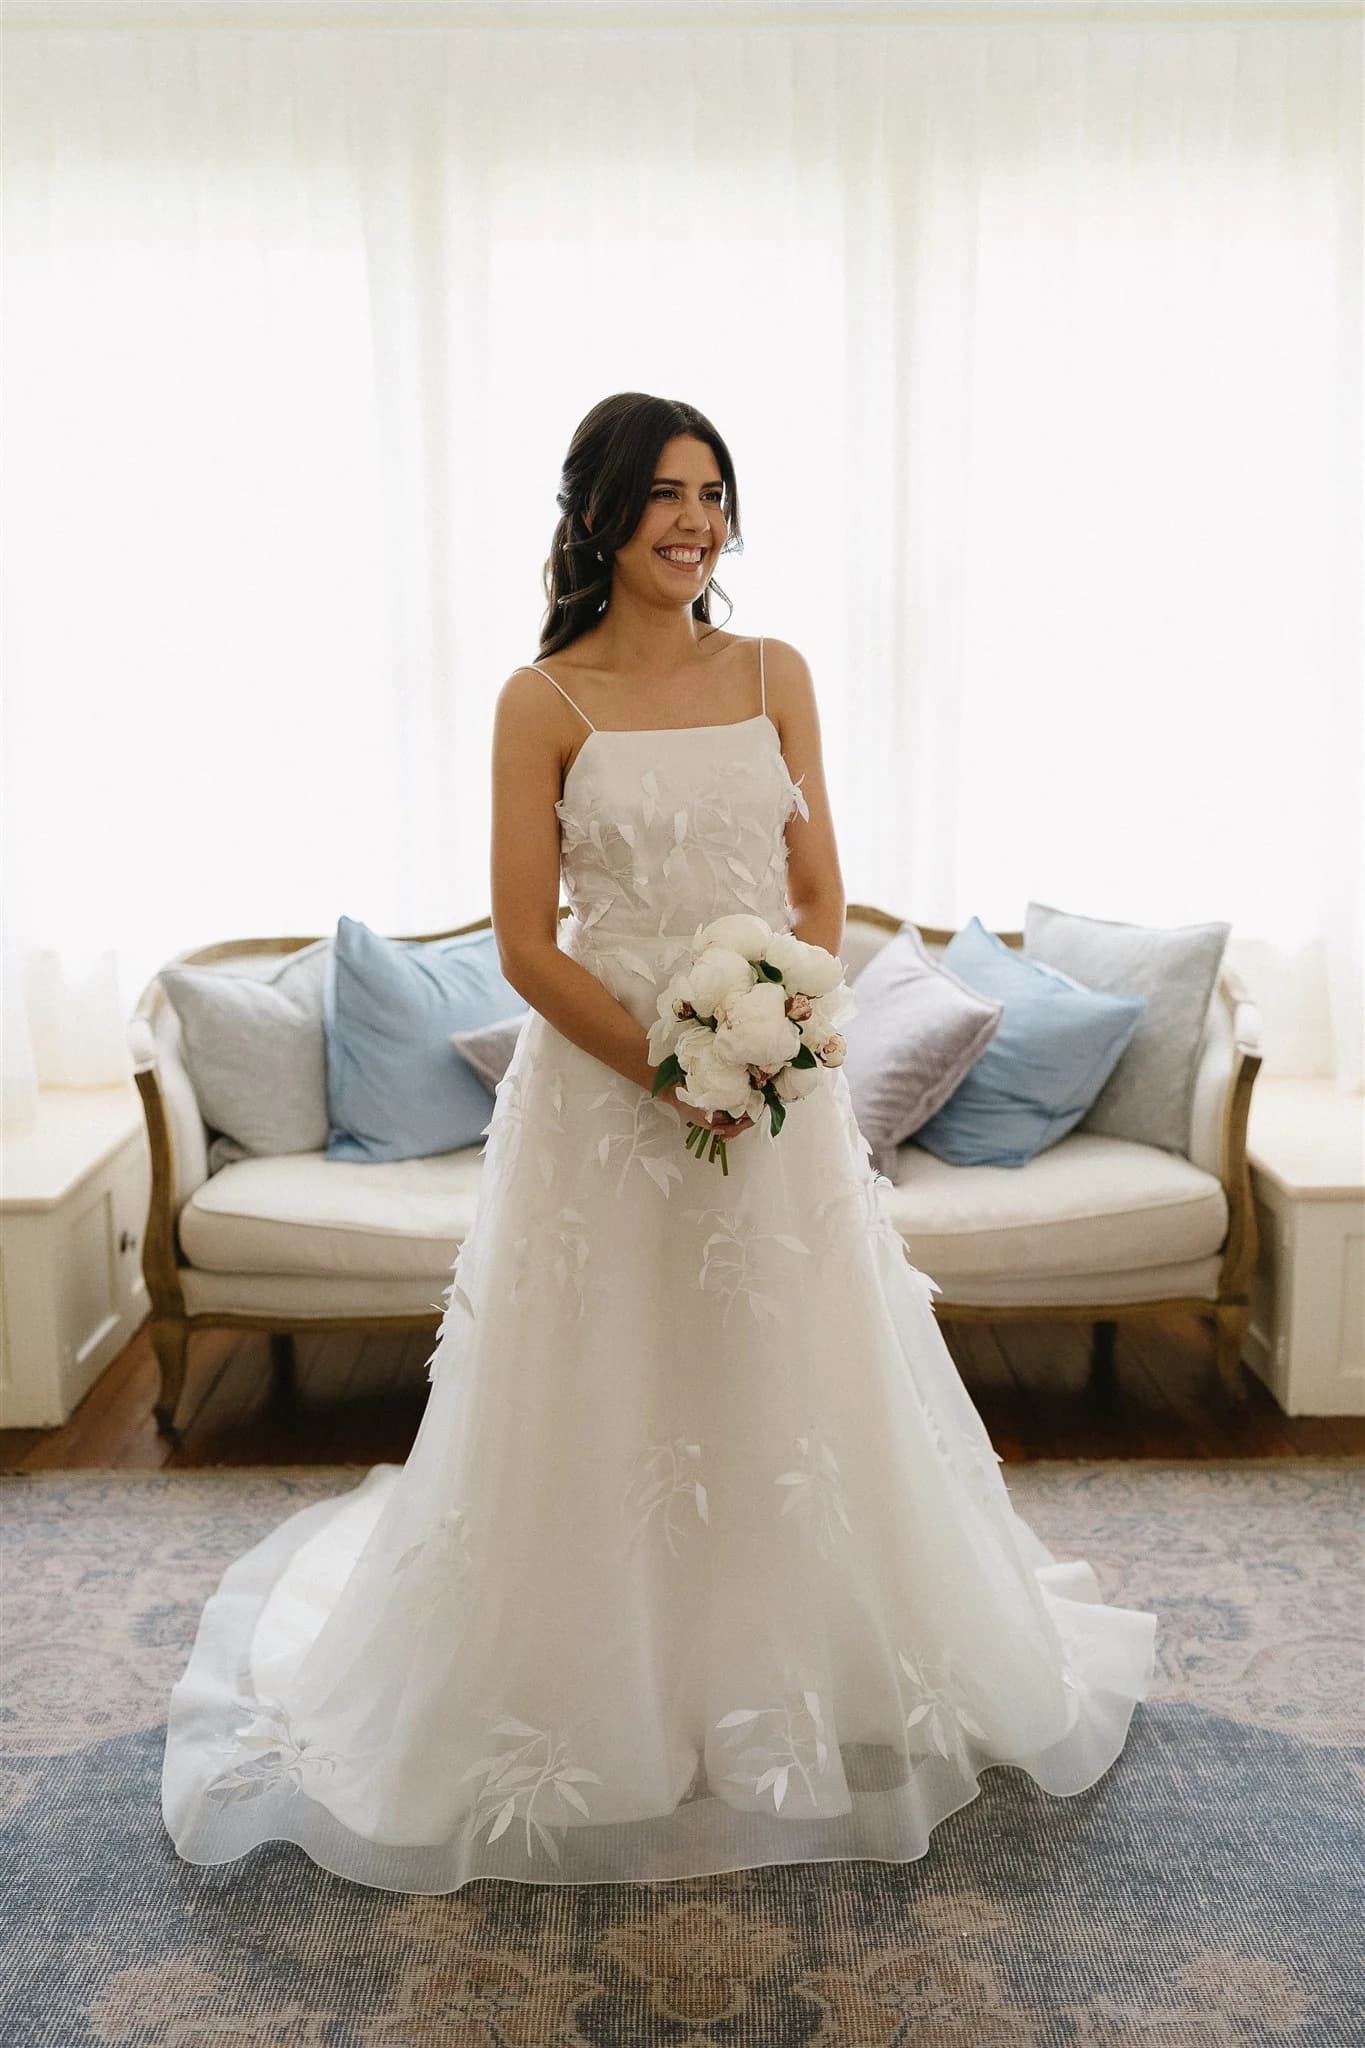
[1023,903,1232,1153]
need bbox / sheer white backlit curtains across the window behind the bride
[2,6,1365,1090]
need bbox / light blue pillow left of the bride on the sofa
[323,918,526,1159]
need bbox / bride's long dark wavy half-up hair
[540,391,745,655]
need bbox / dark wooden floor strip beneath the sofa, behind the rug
[0,1315,1365,1473]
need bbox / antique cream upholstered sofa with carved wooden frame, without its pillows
[129,903,1261,1434]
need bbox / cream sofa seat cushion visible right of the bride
[890,1130,1228,1298]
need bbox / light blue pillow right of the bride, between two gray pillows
[911,918,1146,1165]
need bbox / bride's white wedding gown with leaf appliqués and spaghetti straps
[164,634,1156,1892]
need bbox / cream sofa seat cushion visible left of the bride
[180,1143,483,1278]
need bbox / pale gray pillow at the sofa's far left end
[160,938,332,1171]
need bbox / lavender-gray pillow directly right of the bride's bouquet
[843,924,1005,1180]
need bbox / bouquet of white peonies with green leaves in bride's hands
[649,911,857,1174]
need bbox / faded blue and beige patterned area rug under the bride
[0,1460,1365,2048]
